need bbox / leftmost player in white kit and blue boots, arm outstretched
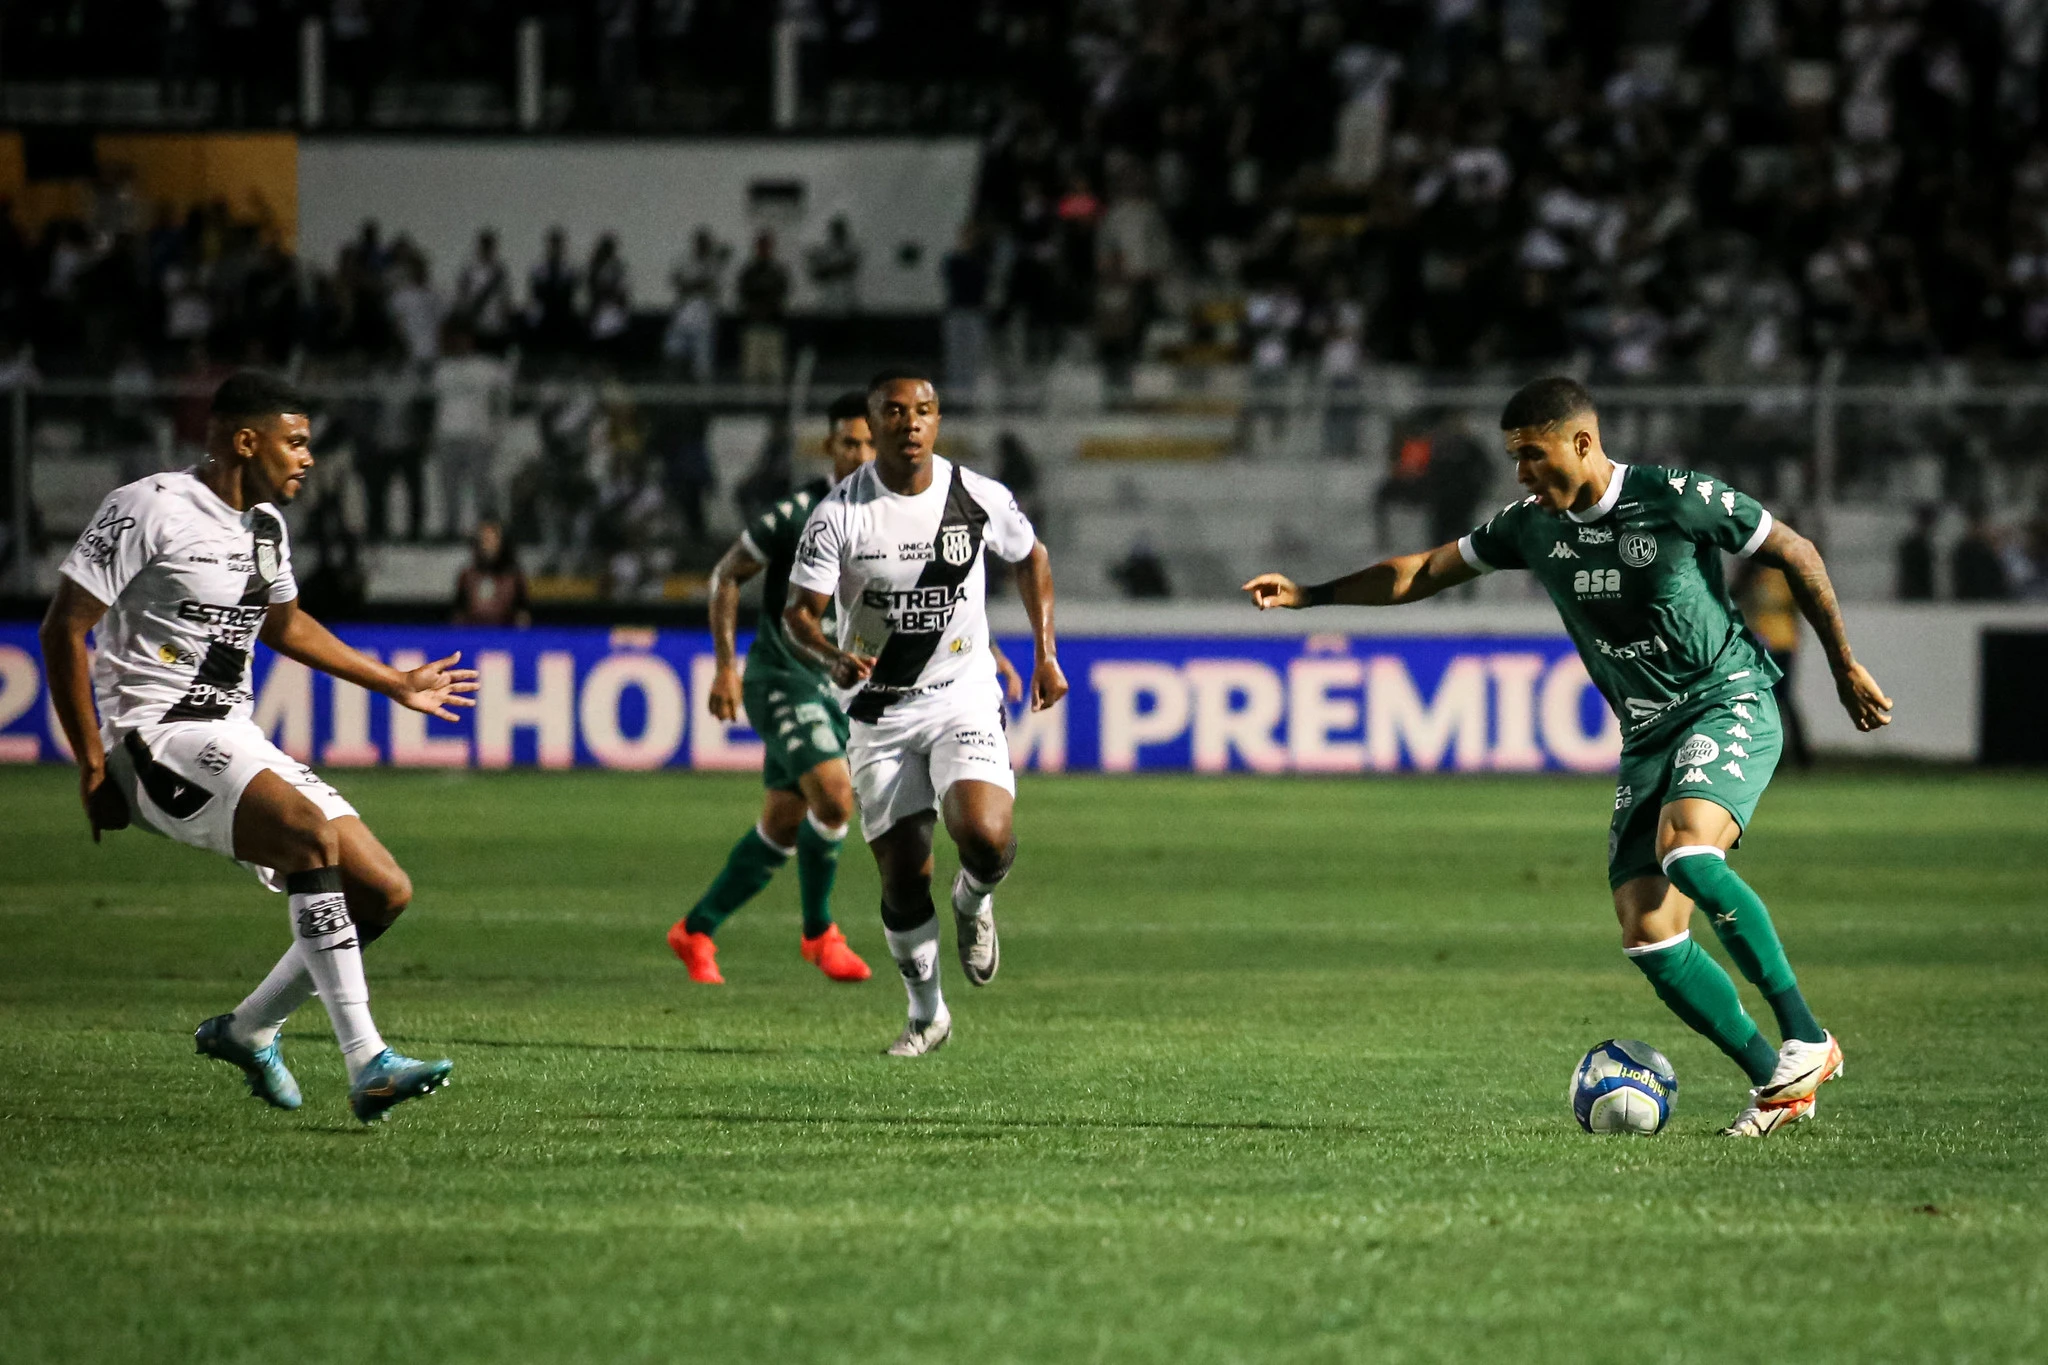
[41,372,477,1124]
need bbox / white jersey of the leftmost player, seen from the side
[59,469,299,731]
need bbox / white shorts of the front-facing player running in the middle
[846,684,1018,843]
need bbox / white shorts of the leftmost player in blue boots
[102,720,356,890]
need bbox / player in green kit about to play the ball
[1245,379,1892,1138]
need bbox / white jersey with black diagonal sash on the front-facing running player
[788,456,1038,692]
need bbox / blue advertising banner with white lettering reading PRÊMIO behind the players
[0,624,1622,774]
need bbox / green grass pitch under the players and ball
[0,769,2048,1365]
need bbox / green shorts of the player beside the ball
[1608,688,1784,886]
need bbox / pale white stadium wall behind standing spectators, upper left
[299,137,981,313]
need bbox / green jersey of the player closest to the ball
[1458,463,1780,741]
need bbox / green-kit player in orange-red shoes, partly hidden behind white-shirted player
[668,393,1022,984]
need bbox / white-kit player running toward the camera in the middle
[782,372,1067,1056]
